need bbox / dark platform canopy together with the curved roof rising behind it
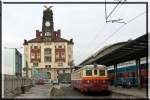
[80,34,148,66]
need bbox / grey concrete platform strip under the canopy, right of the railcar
[109,86,147,98]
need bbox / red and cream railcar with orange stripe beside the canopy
[71,65,108,92]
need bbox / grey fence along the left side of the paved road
[3,75,32,97]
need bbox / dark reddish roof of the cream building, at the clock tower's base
[23,36,74,45]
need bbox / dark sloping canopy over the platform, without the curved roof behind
[94,34,148,65]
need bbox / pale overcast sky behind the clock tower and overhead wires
[2,0,148,70]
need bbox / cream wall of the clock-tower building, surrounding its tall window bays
[24,42,73,79]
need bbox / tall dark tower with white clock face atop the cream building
[42,6,54,40]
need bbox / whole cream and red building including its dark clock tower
[23,7,74,80]
